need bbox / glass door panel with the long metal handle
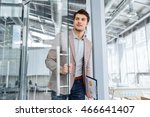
[27,0,69,100]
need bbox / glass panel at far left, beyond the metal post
[0,0,23,100]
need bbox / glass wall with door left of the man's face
[0,0,92,100]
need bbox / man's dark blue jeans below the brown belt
[51,79,85,100]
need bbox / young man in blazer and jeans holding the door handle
[45,9,92,100]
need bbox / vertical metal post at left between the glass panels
[19,0,28,100]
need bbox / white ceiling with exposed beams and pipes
[0,0,150,45]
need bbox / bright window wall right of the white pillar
[108,18,150,99]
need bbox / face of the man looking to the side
[74,14,88,32]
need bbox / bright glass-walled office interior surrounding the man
[0,0,150,100]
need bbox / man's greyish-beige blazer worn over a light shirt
[45,30,92,94]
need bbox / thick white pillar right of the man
[90,0,109,100]
